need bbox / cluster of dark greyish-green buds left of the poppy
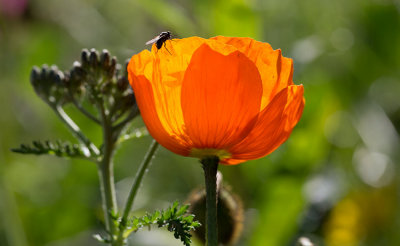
[31,49,137,121]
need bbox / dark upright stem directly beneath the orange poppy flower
[201,156,219,246]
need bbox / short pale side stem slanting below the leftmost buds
[51,106,100,156]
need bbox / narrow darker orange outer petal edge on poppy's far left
[128,51,190,156]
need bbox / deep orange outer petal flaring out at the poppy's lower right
[222,85,304,164]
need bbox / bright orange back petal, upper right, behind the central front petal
[212,36,293,110]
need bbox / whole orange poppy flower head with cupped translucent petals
[128,37,304,164]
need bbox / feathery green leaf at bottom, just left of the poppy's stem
[124,202,200,246]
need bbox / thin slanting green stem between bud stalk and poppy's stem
[117,140,159,245]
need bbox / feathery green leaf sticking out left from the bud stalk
[11,140,89,159]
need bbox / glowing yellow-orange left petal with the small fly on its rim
[128,37,244,155]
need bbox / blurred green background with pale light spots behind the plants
[0,0,400,246]
